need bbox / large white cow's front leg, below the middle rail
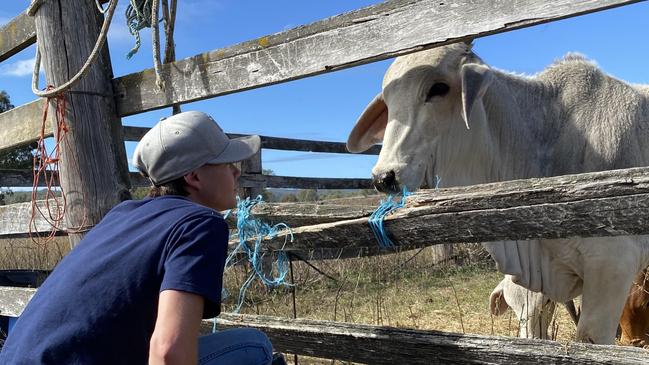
[577,243,636,344]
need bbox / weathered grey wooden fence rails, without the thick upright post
[0,0,649,364]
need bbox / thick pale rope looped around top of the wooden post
[28,0,117,98]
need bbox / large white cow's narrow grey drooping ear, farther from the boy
[460,63,493,129]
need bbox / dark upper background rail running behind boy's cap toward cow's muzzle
[123,126,381,155]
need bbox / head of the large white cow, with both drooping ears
[347,43,492,192]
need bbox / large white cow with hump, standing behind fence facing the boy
[347,44,649,344]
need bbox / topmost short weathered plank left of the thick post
[0,11,36,62]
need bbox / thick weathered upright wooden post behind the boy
[34,0,130,246]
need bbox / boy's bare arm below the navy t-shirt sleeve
[149,290,205,365]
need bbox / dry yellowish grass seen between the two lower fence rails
[224,245,575,341]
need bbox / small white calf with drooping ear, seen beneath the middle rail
[489,275,556,339]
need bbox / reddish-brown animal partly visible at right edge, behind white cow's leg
[620,269,649,346]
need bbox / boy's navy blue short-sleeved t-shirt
[0,196,228,365]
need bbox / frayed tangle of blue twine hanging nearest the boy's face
[213,195,293,330]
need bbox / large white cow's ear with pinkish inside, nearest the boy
[347,93,388,153]
